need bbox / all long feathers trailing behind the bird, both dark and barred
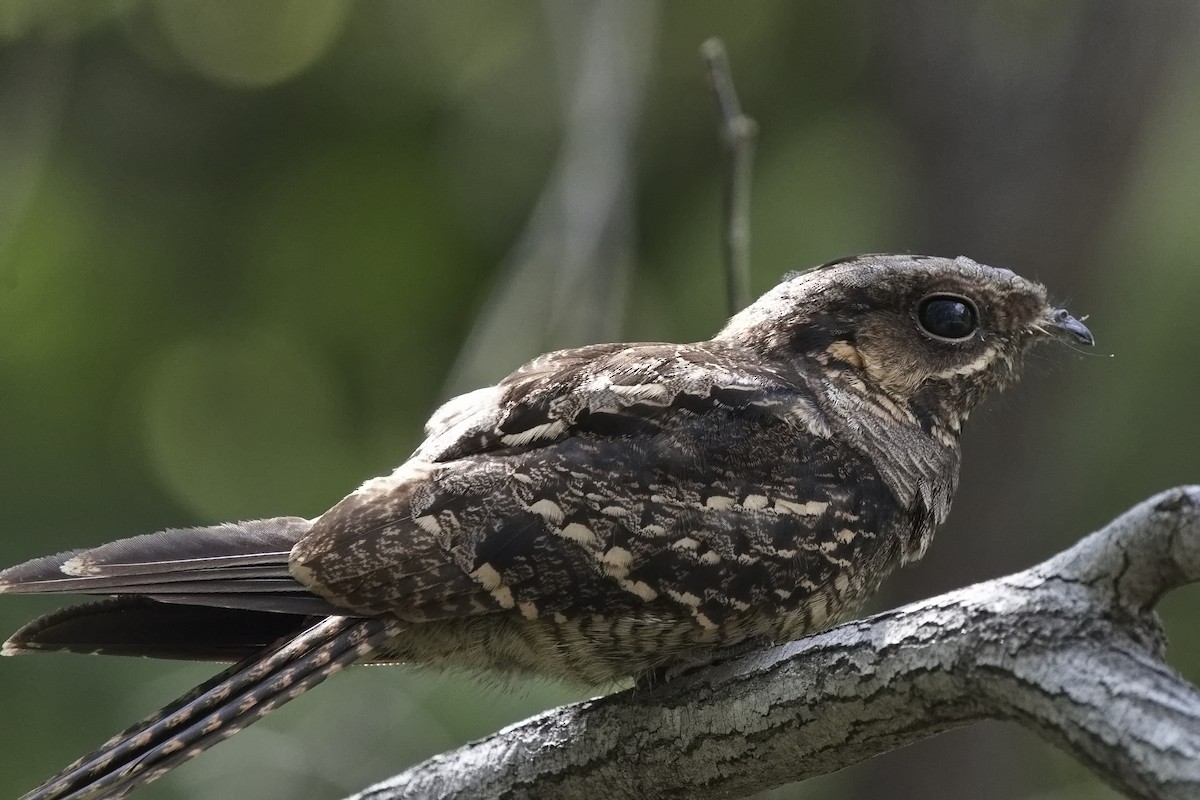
[0,517,401,800]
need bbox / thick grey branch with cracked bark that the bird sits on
[345,486,1200,800]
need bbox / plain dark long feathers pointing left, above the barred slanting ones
[0,517,353,661]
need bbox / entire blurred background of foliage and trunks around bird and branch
[0,0,1200,800]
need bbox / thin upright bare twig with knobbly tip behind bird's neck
[700,38,758,314]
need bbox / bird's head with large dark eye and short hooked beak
[716,255,1092,419]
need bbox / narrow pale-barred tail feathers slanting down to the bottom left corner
[22,616,401,800]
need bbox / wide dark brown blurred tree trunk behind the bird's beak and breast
[860,6,1198,800]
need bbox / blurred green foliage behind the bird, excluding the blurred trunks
[0,0,1200,798]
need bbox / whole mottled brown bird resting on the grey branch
[0,254,1093,800]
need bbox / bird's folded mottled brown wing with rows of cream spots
[293,343,896,624]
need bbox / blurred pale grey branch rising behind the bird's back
[444,0,658,397]
